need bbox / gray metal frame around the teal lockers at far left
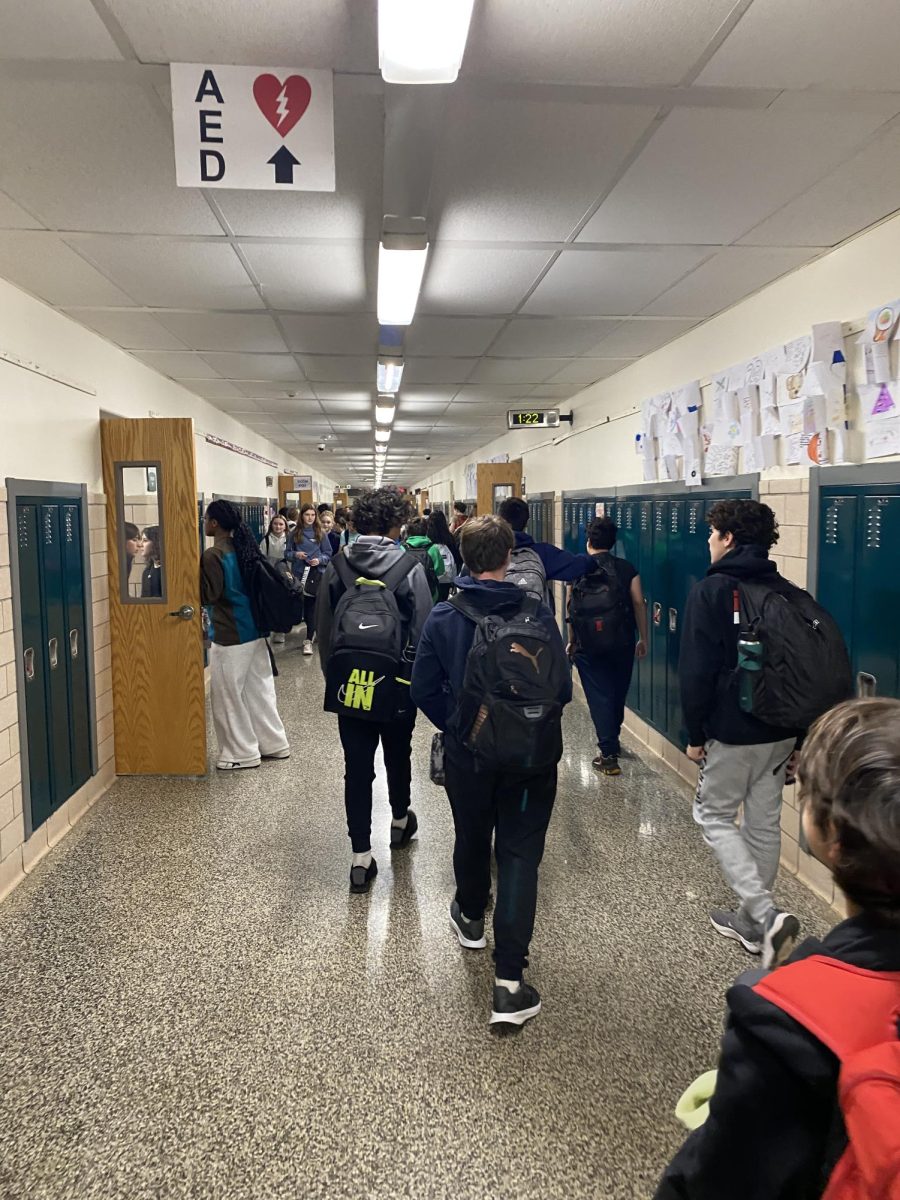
[6,479,98,841]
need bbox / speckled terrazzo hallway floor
[0,640,832,1200]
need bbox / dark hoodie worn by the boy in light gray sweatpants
[678,546,803,746]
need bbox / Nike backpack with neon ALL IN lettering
[325,554,418,721]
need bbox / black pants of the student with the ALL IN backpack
[337,709,415,854]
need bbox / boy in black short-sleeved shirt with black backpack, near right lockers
[569,517,647,775]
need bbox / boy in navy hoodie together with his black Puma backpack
[413,516,571,1025]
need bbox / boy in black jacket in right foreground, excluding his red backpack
[656,698,900,1200]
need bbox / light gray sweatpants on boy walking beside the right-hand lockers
[694,738,794,925]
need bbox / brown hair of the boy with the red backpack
[798,697,900,924]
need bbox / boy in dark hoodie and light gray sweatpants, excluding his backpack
[678,500,803,967]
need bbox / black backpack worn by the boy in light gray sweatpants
[736,576,853,731]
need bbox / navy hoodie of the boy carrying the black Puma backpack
[412,576,572,749]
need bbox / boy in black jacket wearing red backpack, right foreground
[655,698,900,1200]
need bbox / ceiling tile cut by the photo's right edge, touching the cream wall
[740,127,900,246]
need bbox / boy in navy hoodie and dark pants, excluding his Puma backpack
[413,516,572,1025]
